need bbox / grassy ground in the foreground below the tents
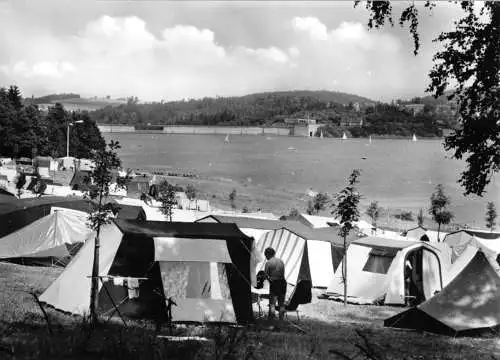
[0,263,500,360]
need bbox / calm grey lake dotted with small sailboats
[104,133,500,227]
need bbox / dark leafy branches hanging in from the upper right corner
[354,0,500,196]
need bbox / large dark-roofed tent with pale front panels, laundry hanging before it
[40,219,253,323]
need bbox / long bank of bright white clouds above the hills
[0,15,423,100]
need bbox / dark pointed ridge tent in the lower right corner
[384,251,500,336]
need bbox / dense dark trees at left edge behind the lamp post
[0,86,105,158]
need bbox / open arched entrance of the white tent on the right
[404,247,443,306]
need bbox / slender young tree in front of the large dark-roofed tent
[85,141,128,326]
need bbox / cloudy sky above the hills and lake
[0,0,468,101]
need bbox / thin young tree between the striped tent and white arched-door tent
[332,169,361,305]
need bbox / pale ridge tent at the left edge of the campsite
[0,210,90,265]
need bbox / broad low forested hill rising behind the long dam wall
[91,91,374,125]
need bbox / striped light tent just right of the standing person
[256,222,358,288]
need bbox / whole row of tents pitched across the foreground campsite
[0,198,500,332]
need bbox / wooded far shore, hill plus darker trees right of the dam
[83,92,448,137]
